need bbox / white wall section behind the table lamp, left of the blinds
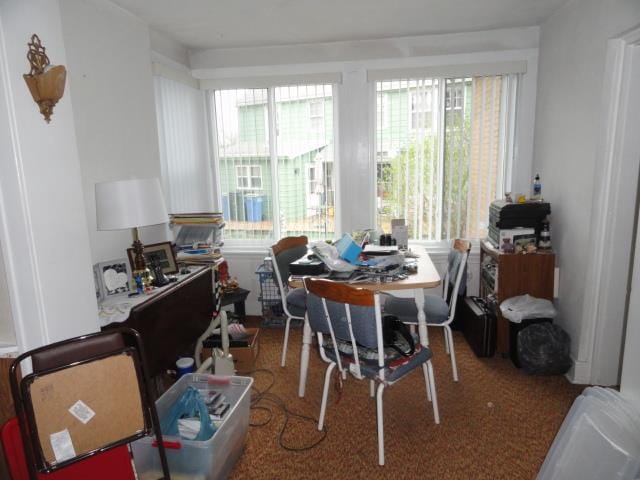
[61,0,167,263]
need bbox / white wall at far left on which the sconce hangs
[0,0,98,350]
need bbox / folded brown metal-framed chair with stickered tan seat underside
[9,328,170,480]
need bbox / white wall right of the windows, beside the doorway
[533,0,640,384]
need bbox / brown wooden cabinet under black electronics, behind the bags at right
[480,241,556,354]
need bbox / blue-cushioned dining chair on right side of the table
[384,239,471,382]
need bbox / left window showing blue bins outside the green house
[214,85,335,240]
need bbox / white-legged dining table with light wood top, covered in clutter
[288,249,440,397]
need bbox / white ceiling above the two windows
[112,0,567,49]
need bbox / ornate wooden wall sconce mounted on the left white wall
[23,33,67,123]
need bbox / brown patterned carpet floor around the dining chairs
[230,322,584,480]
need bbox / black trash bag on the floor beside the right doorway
[518,323,571,375]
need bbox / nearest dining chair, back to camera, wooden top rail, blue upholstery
[304,277,440,465]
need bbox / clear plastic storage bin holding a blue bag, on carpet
[132,373,253,480]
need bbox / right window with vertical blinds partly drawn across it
[376,76,515,240]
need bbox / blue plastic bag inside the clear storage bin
[160,386,215,441]
